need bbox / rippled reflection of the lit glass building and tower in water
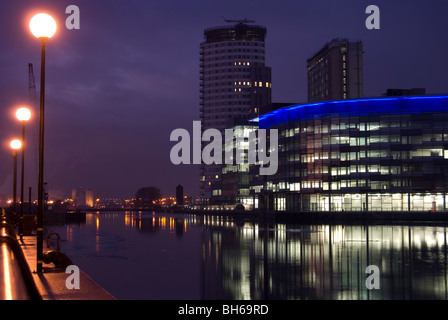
[202,222,447,300]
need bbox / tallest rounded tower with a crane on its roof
[200,20,271,201]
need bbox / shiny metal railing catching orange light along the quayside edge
[0,211,42,300]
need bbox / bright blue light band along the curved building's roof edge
[253,95,448,129]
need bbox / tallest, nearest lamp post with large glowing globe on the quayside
[30,13,57,273]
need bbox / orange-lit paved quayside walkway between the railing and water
[19,235,116,300]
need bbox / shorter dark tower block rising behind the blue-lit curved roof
[307,39,363,102]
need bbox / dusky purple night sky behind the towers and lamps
[0,0,448,198]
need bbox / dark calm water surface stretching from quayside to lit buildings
[46,212,448,300]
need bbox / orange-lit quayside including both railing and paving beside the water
[0,212,116,300]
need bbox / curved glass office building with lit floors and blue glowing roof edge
[251,95,448,211]
